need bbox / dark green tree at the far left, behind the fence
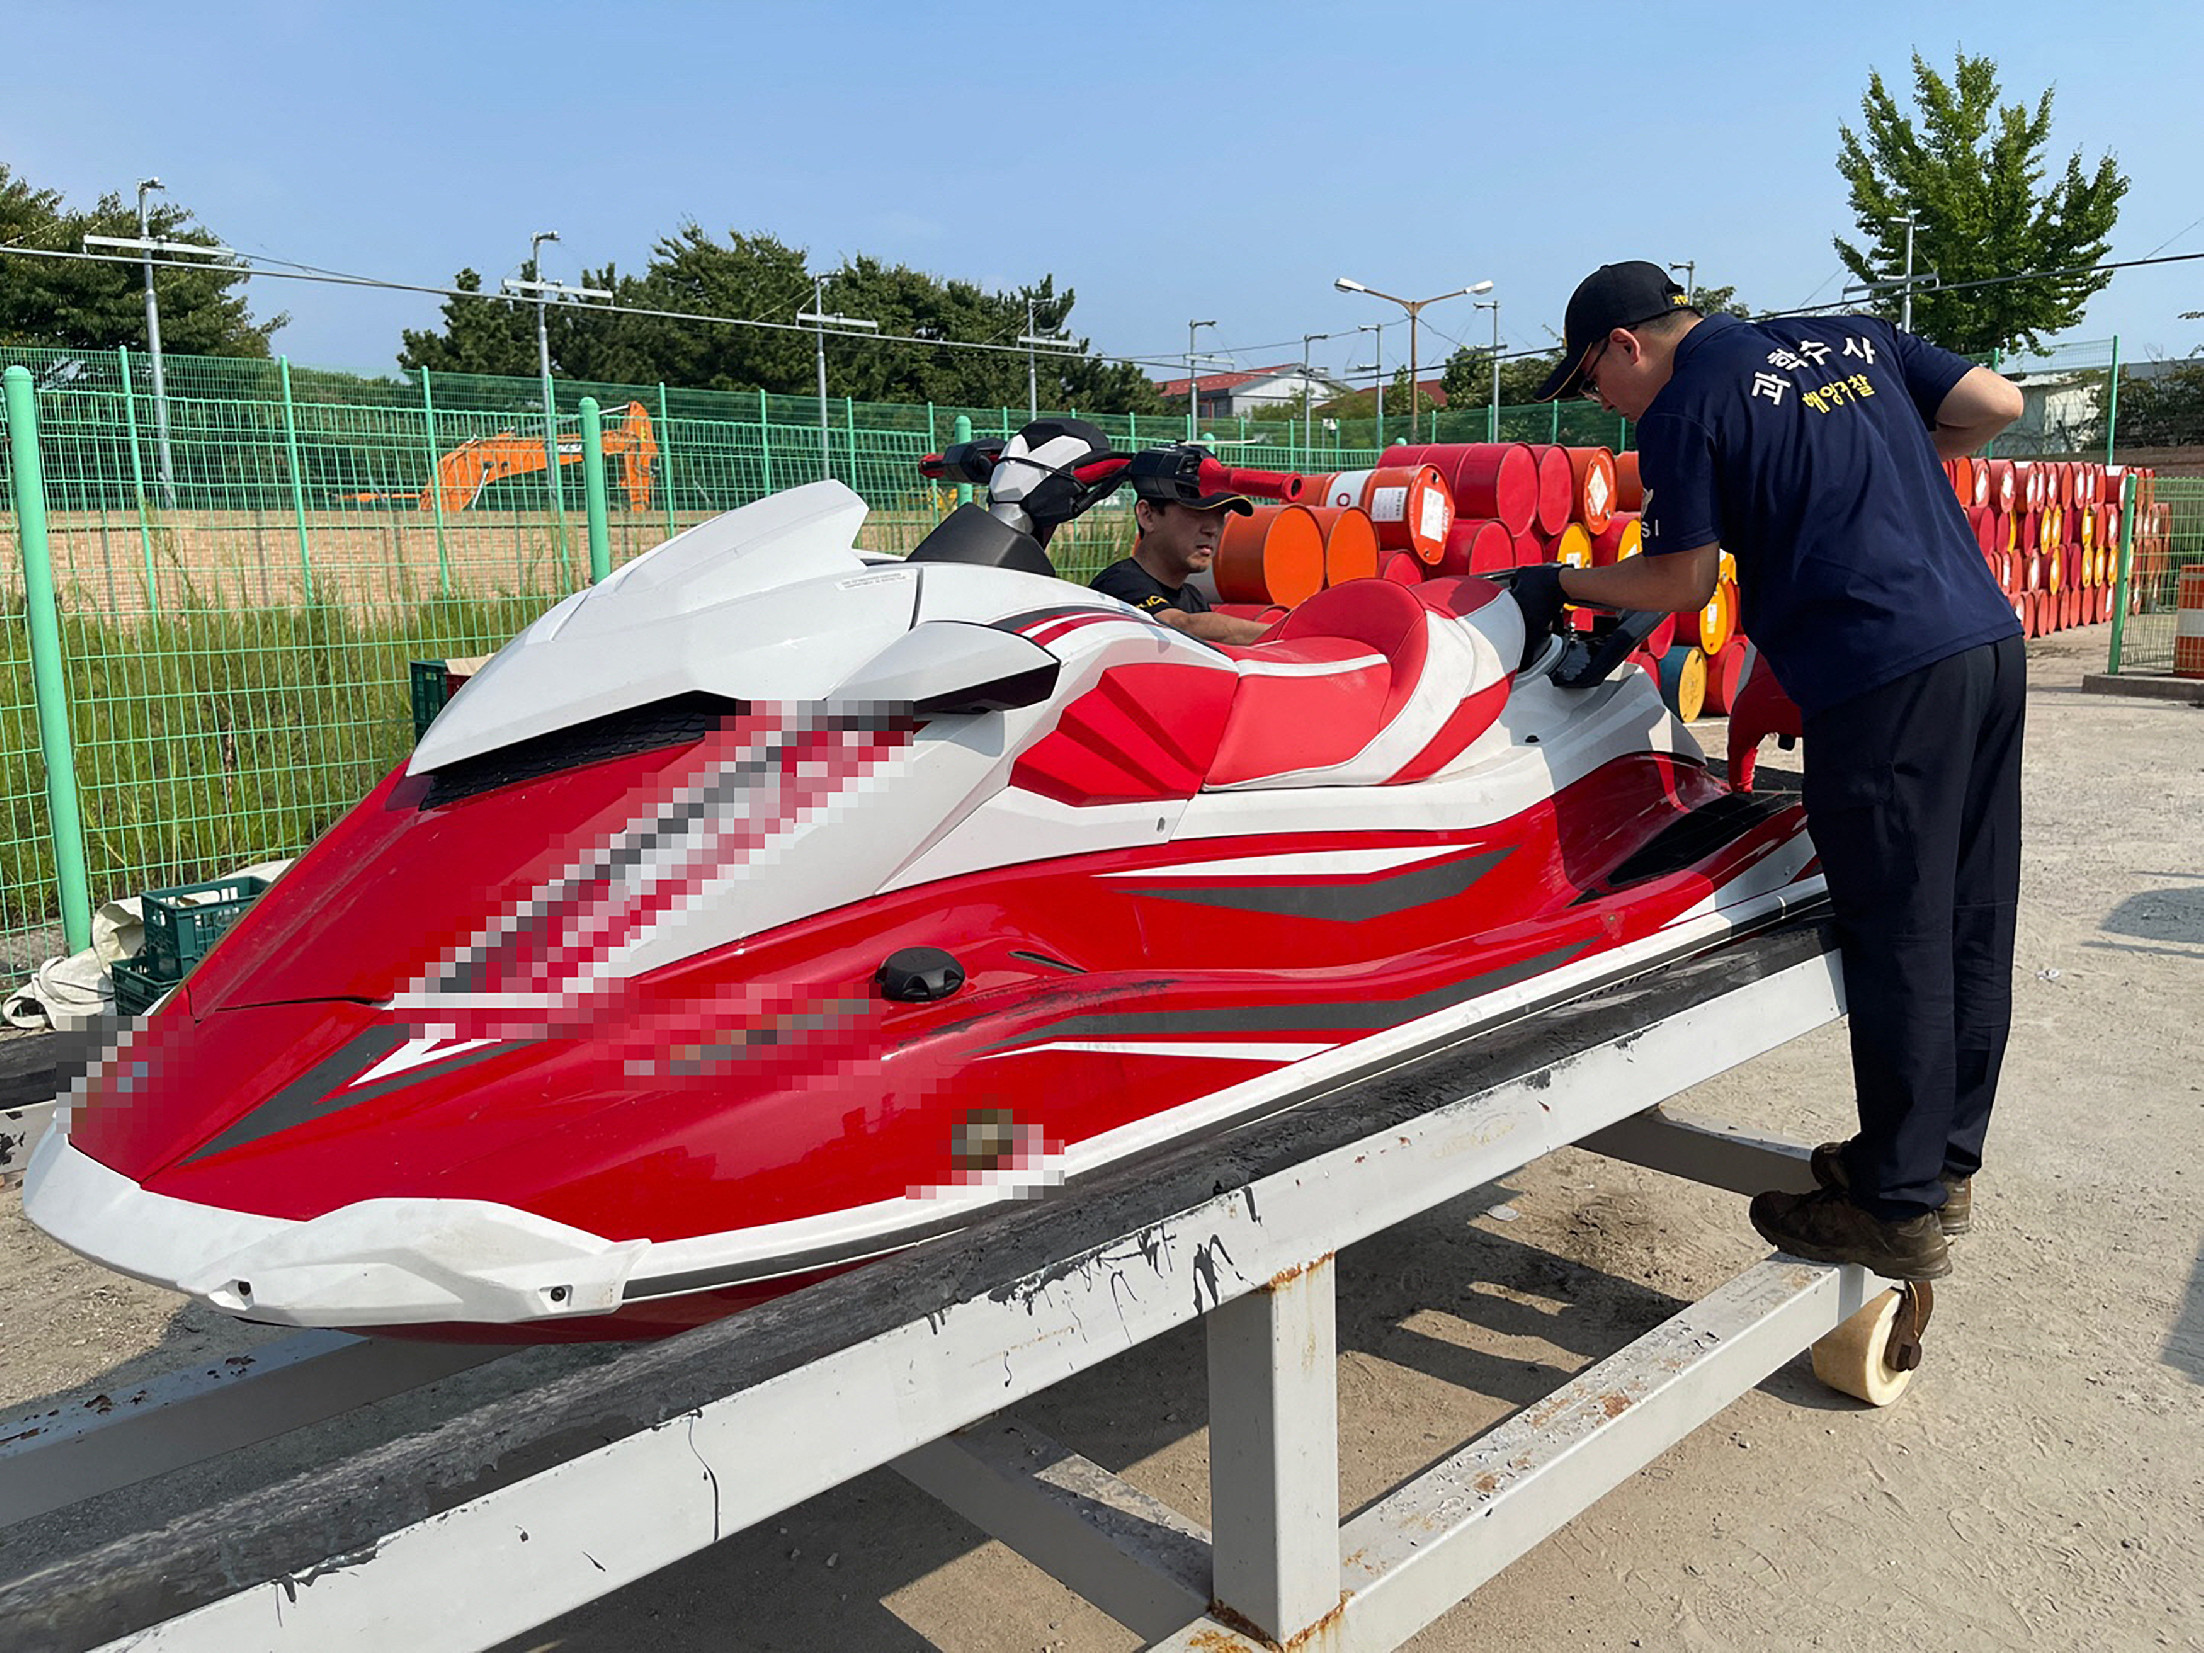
[0,165,289,357]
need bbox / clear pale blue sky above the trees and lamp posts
[0,0,2204,372]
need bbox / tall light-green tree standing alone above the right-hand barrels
[1834,51,2127,355]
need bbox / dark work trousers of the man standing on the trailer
[1803,637,2028,1219]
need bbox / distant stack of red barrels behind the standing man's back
[1944,458,2169,637]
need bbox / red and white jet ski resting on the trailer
[26,421,1821,1342]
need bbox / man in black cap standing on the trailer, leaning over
[1516,262,2025,1281]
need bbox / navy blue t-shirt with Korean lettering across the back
[1638,315,2021,714]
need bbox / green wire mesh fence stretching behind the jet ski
[0,348,2195,972]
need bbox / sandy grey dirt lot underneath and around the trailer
[0,630,2204,1653]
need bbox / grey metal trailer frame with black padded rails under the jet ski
[0,919,1884,1653]
